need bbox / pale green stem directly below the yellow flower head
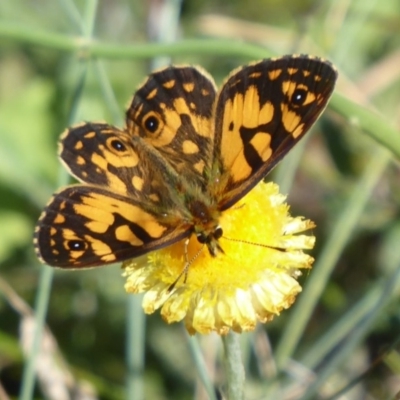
[222,332,245,400]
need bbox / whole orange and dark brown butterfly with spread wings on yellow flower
[34,55,337,268]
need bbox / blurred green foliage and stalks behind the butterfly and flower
[0,0,400,400]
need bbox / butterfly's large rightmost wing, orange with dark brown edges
[214,56,337,210]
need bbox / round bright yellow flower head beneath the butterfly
[123,183,315,335]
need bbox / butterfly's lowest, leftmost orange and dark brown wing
[34,185,189,268]
